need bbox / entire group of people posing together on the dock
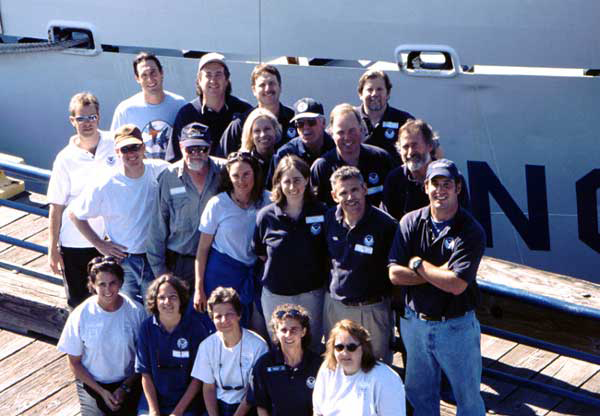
[48,53,485,416]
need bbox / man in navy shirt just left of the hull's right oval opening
[357,69,414,166]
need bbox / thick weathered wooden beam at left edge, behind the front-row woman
[0,270,68,338]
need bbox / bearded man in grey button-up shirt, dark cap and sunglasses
[146,123,223,287]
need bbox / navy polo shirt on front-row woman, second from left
[135,302,210,412]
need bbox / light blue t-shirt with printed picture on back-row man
[110,91,187,159]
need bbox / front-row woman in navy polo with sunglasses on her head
[250,304,322,416]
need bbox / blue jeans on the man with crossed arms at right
[400,307,485,416]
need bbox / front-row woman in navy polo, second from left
[135,274,210,416]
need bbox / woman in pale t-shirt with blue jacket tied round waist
[194,152,270,326]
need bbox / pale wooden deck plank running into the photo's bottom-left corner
[0,356,73,416]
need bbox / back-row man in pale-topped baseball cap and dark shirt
[166,52,252,162]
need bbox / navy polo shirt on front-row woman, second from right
[248,348,322,416]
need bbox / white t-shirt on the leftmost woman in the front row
[57,294,147,383]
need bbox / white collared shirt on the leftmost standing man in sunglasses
[47,130,120,248]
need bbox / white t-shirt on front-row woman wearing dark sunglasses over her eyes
[313,362,406,416]
